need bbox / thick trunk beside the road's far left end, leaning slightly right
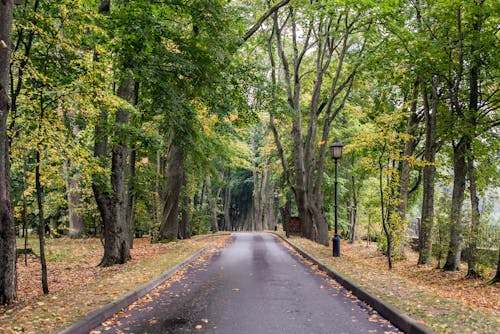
[159,138,184,241]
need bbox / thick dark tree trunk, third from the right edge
[443,136,468,271]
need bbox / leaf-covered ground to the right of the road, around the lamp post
[282,237,500,334]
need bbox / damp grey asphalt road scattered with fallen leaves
[95,233,398,334]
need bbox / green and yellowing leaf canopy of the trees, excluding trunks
[5,0,500,276]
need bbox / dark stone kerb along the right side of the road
[271,233,435,334]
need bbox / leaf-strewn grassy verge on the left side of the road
[0,236,230,334]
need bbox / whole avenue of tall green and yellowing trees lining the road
[0,0,500,304]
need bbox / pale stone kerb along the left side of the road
[58,246,211,334]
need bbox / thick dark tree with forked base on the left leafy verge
[93,1,150,266]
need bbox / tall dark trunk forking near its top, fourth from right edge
[418,79,438,264]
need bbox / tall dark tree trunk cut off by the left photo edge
[0,0,17,304]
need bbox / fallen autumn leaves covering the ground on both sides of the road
[0,232,500,333]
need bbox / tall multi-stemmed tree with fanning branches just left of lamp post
[270,3,373,245]
